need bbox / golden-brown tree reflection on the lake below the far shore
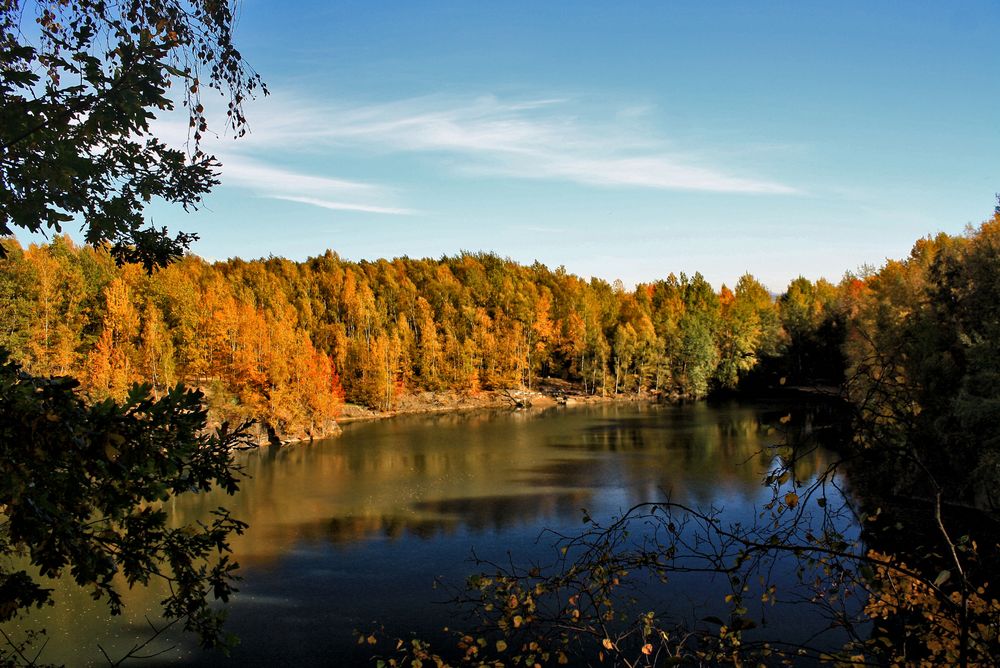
[173,403,825,566]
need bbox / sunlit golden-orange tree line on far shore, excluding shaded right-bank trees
[0,236,842,434]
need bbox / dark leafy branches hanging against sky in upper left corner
[0,0,267,268]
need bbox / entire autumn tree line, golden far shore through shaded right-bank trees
[7,204,998,464]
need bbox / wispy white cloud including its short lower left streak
[150,92,797,216]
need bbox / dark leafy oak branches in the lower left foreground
[0,354,252,646]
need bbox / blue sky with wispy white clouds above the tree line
[131,0,1000,291]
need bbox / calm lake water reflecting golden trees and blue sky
[9,402,852,666]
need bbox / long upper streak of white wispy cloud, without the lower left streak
[232,96,797,194]
